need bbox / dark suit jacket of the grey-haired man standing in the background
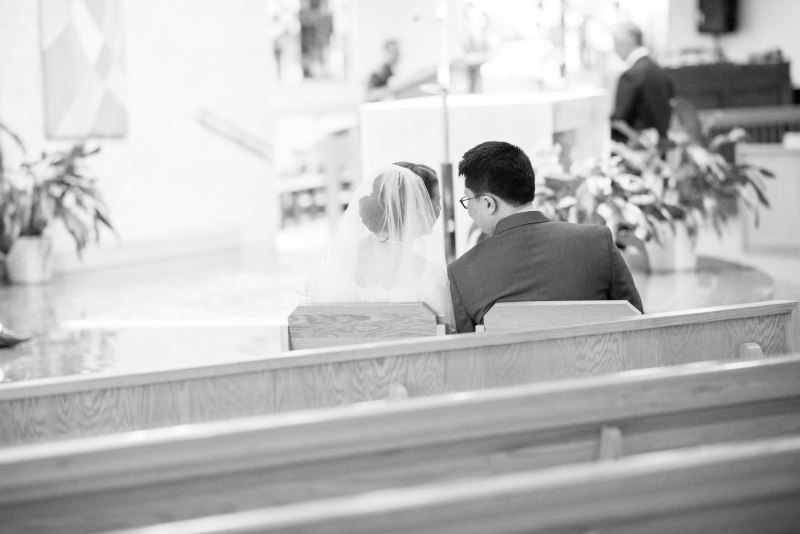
[611,56,675,141]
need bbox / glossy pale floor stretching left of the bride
[0,225,326,381]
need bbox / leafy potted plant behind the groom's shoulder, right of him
[535,104,772,271]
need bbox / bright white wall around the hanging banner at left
[0,0,278,272]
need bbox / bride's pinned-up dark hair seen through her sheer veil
[358,161,441,234]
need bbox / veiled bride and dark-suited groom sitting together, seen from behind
[306,141,643,333]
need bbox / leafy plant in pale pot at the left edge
[0,125,113,283]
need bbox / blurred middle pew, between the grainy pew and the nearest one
[0,355,800,533]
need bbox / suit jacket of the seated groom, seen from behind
[447,211,643,332]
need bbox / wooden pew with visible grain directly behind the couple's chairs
[0,301,800,445]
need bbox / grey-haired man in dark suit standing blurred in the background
[611,23,675,146]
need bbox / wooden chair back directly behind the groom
[475,300,641,333]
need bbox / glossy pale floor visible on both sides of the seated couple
[0,218,800,382]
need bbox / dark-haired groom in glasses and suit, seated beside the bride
[447,141,643,332]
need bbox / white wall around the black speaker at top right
[669,0,800,86]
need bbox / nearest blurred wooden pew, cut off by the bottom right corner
[111,436,800,534]
